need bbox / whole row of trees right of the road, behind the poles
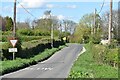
[71,10,119,43]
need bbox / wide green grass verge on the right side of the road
[68,44,118,78]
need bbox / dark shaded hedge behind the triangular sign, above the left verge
[2,39,65,60]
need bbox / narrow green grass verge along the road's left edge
[0,46,65,74]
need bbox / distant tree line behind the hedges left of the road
[0,11,77,40]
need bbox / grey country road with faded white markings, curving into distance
[3,44,82,80]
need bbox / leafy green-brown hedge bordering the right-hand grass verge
[92,45,118,67]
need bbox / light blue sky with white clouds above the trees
[0,0,118,23]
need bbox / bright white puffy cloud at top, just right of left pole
[17,0,45,8]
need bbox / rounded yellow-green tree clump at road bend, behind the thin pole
[71,13,102,44]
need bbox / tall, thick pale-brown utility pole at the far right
[108,0,112,44]
